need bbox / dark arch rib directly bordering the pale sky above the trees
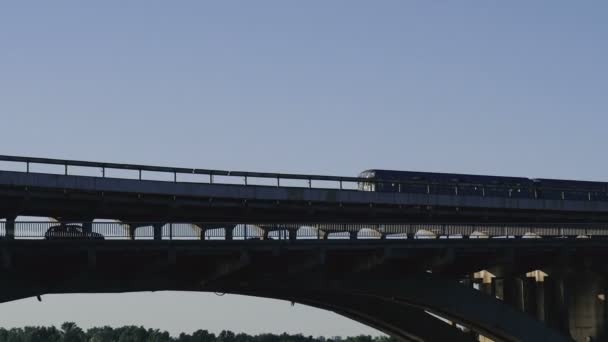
[0,272,475,342]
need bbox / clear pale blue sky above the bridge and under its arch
[0,0,608,335]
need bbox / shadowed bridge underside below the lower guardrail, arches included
[0,240,592,341]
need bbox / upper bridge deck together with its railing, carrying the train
[0,156,608,223]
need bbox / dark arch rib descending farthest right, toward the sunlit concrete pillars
[204,274,569,342]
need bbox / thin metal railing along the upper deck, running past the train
[0,155,608,201]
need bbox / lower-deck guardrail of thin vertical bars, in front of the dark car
[0,221,608,241]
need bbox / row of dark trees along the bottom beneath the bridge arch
[0,322,396,342]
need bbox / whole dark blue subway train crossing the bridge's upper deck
[358,170,608,201]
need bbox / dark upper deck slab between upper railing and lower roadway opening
[0,171,608,222]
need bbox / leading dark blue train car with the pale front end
[359,169,534,198]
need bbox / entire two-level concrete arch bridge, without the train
[0,156,608,341]
